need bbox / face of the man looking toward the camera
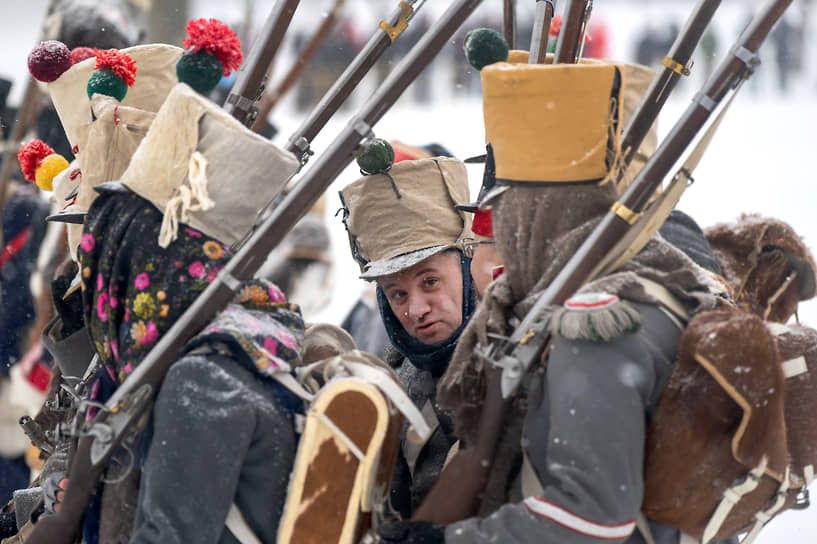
[377,251,462,344]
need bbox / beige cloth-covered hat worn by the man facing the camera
[341,157,471,279]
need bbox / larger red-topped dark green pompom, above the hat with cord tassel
[176,19,243,95]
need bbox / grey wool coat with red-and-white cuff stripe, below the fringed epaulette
[445,304,740,544]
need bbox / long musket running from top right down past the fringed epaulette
[413,0,792,525]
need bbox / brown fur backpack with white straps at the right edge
[642,215,817,543]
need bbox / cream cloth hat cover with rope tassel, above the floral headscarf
[121,83,300,247]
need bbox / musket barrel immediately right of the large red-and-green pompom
[224,0,300,127]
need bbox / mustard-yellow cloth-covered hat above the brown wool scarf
[480,51,655,188]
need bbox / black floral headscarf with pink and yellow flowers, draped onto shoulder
[78,191,303,384]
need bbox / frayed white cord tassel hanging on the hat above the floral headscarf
[159,151,215,247]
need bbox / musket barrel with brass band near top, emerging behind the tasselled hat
[284,0,425,164]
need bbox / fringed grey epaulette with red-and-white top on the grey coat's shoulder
[551,293,641,342]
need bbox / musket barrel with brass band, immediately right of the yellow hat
[621,0,721,178]
